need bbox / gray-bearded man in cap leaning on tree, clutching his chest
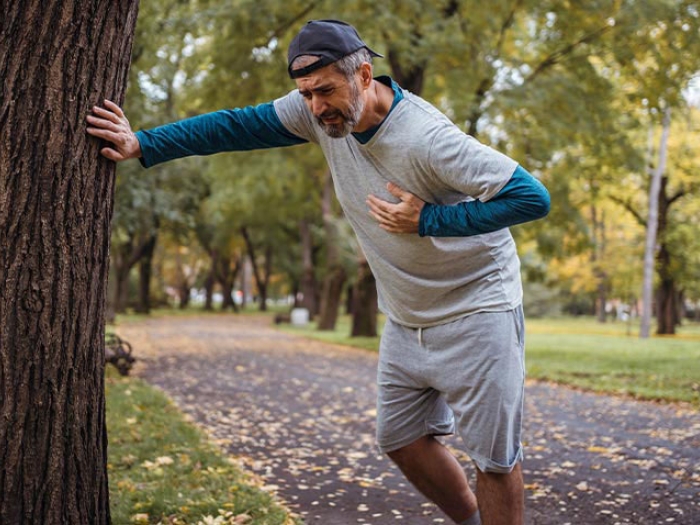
[88,20,549,525]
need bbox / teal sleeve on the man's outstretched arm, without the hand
[136,102,307,168]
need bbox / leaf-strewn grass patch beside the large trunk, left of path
[106,366,296,525]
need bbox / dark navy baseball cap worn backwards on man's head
[287,20,383,78]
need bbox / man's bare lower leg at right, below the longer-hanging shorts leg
[476,463,525,525]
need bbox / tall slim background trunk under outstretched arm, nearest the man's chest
[318,171,347,330]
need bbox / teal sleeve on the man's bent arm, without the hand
[418,166,550,237]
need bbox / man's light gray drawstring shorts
[377,307,525,473]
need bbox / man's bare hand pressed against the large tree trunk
[87,100,141,162]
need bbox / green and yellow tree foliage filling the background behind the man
[114,0,700,316]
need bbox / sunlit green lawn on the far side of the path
[284,316,700,409]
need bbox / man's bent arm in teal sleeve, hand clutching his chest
[367,166,550,237]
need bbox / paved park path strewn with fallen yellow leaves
[117,315,700,525]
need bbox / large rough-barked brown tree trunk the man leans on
[0,0,138,525]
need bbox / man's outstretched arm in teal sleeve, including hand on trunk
[88,101,307,164]
